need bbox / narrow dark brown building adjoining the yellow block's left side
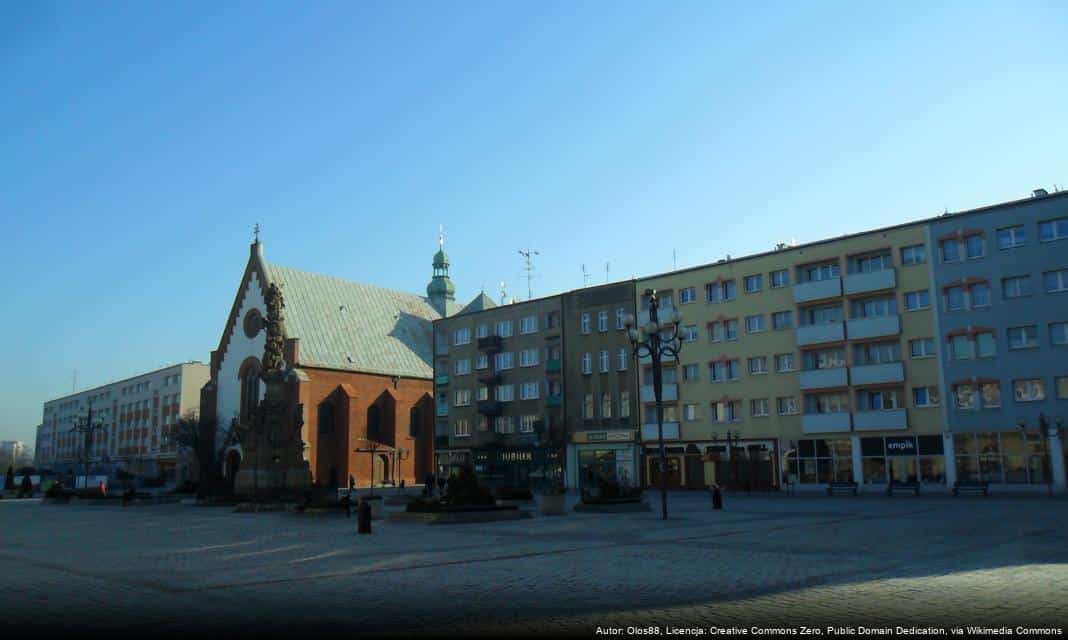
[552,282,641,488]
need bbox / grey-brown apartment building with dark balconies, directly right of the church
[434,294,565,486]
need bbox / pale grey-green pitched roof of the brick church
[263,261,440,378]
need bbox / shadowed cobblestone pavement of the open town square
[0,494,1068,637]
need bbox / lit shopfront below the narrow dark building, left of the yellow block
[567,431,639,488]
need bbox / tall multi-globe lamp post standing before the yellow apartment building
[624,288,682,520]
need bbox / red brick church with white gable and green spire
[201,238,456,486]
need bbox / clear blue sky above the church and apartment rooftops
[0,0,1068,441]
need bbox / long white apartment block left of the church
[36,362,210,478]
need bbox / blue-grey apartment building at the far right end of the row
[930,190,1068,490]
